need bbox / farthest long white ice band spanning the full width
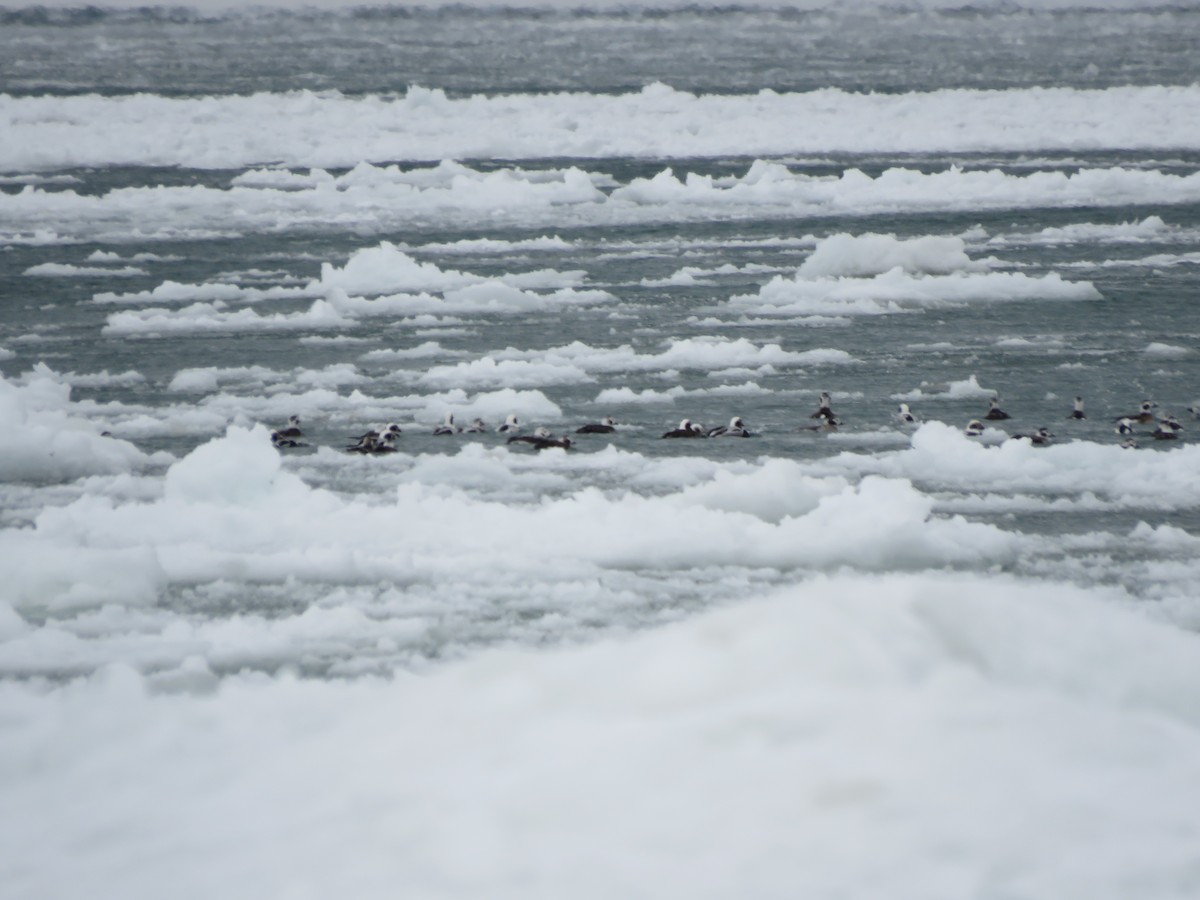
[0,84,1200,172]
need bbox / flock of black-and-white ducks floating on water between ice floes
[271,392,1200,455]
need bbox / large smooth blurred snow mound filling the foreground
[0,575,1200,900]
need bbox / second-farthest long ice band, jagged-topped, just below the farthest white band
[9,154,1200,244]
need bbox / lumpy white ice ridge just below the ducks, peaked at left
[0,427,1018,624]
